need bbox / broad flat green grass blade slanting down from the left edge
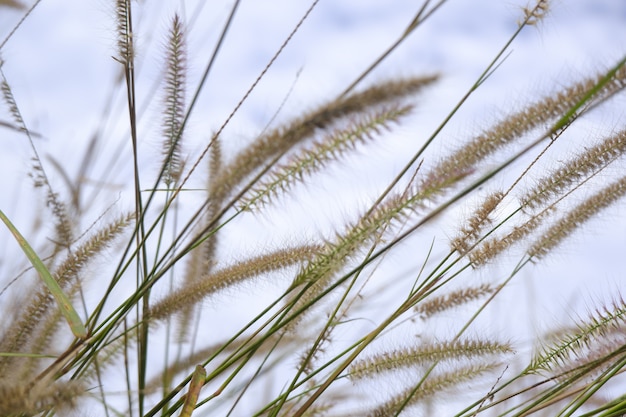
[0,210,87,339]
